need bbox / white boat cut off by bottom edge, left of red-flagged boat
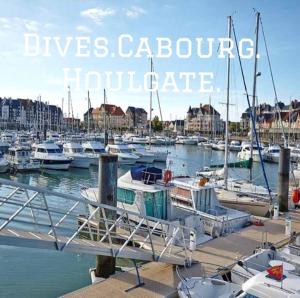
[177,277,241,298]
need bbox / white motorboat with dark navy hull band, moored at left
[33,140,73,170]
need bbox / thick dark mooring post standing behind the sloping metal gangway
[95,154,118,278]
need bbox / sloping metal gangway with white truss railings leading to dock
[0,179,191,265]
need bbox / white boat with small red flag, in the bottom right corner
[231,247,300,298]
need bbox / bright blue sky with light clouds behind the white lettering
[0,0,300,121]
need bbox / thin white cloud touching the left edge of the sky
[0,17,54,32]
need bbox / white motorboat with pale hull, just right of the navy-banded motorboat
[63,142,91,169]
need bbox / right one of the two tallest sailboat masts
[249,12,260,181]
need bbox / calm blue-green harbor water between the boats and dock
[0,145,277,298]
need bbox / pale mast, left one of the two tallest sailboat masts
[224,16,232,189]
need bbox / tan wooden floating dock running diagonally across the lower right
[64,211,300,298]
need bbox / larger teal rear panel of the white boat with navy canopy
[144,191,167,219]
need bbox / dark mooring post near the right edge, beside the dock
[277,148,290,212]
